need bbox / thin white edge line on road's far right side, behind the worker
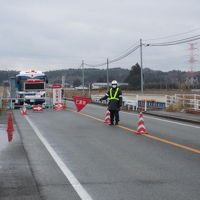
[67,100,200,129]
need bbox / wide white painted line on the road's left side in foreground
[25,115,92,200]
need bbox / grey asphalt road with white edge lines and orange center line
[7,102,200,200]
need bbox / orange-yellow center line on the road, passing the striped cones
[66,109,200,154]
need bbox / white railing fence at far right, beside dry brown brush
[166,94,200,111]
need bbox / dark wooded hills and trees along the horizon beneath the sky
[0,66,200,90]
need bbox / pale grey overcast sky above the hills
[0,0,200,71]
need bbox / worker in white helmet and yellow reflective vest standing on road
[100,80,122,125]
